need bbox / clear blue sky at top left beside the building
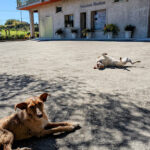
[0,0,38,25]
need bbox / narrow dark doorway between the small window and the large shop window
[80,12,86,38]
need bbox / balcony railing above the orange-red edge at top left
[17,0,41,8]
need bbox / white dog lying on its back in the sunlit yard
[94,53,141,69]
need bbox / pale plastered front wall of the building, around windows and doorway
[34,0,149,38]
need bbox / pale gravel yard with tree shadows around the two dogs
[0,41,150,150]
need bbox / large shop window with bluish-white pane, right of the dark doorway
[91,10,106,30]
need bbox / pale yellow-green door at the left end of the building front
[40,17,53,38]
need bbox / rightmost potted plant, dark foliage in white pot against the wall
[124,25,135,39]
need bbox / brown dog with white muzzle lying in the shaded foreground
[0,93,80,150]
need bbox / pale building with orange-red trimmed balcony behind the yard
[17,0,150,39]
